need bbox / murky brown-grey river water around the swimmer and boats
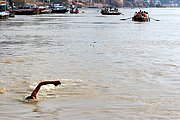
[0,8,180,120]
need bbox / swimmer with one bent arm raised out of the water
[25,80,61,100]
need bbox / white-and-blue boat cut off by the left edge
[0,1,10,19]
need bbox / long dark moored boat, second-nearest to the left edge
[14,5,40,15]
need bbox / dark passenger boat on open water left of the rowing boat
[101,7,122,15]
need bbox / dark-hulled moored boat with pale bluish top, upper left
[51,4,69,13]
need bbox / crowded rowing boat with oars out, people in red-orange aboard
[132,10,150,22]
